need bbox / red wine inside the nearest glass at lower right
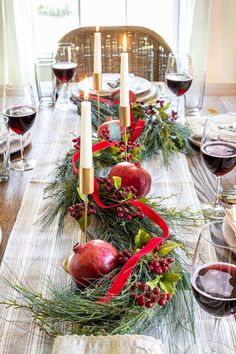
[192,262,236,317]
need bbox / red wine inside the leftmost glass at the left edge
[3,106,36,135]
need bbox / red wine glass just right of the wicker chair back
[165,53,193,117]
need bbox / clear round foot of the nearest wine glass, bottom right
[185,340,234,354]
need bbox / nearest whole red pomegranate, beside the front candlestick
[69,240,118,289]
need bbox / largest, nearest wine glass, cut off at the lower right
[186,218,236,354]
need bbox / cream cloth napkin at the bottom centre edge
[52,335,165,354]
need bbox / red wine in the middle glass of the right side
[201,141,236,176]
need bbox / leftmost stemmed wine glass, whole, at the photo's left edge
[3,84,36,172]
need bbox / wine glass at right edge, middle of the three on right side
[201,114,236,219]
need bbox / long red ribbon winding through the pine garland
[72,141,169,302]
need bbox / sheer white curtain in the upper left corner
[0,0,35,84]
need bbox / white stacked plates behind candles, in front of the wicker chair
[76,74,151,96]
